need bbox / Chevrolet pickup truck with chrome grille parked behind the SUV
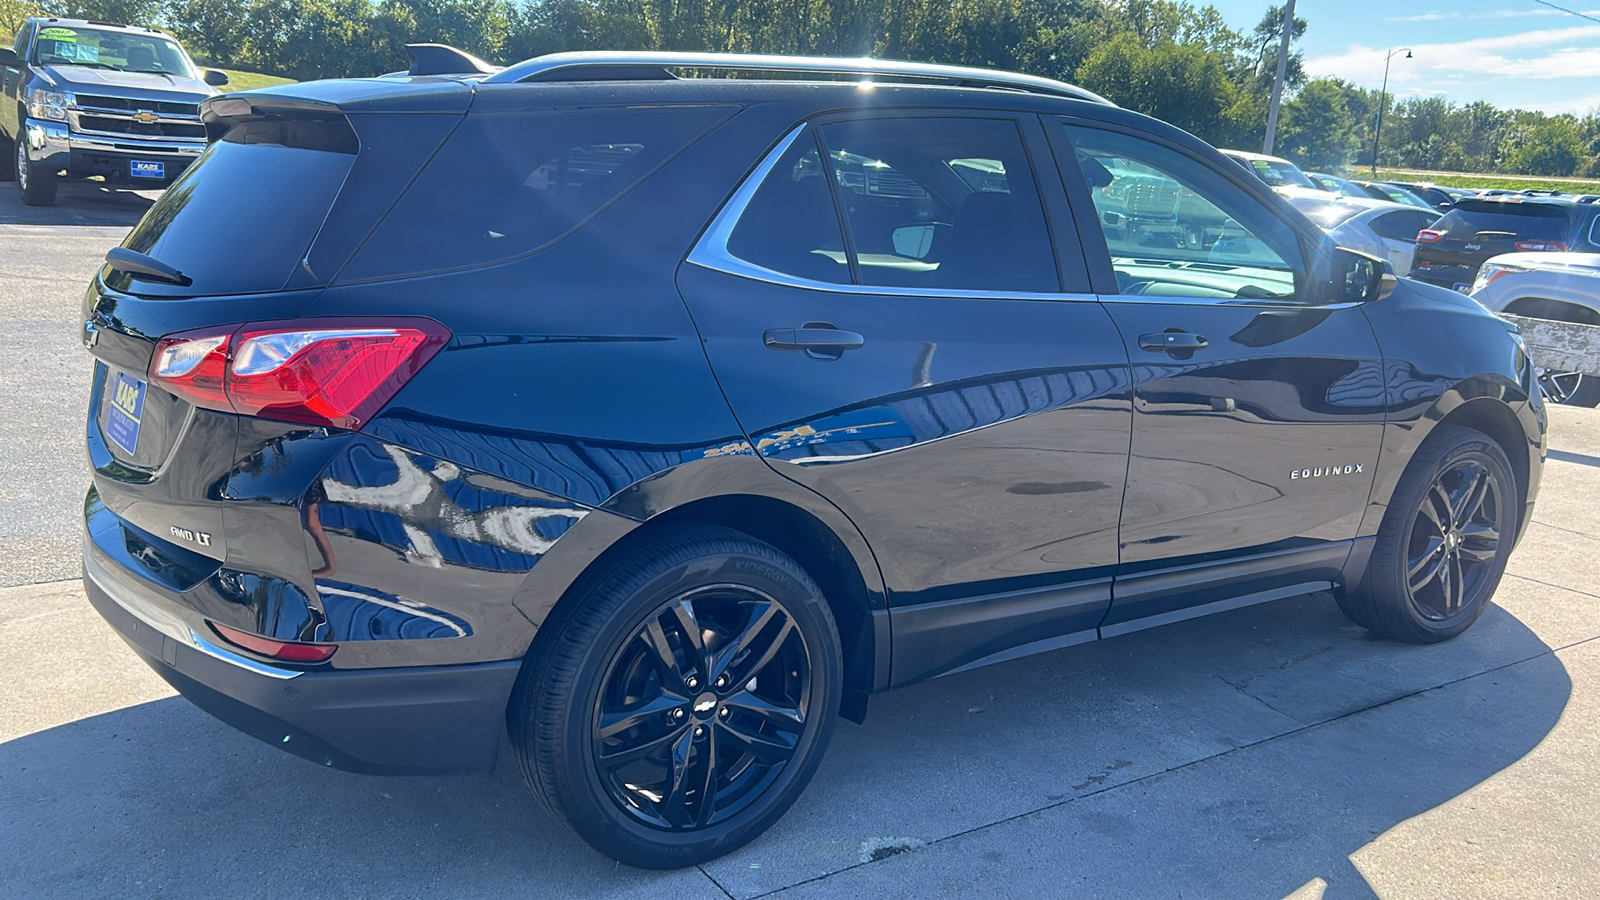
[0,18,227,207]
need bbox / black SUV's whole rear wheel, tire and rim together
[507,525,843,868]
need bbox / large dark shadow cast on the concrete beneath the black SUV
[0,596,1571,897]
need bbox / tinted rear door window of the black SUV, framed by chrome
[728,117,1061,293]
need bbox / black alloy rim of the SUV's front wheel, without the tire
[1406,455,1506,621]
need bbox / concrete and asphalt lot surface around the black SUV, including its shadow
[0,187,1600,898]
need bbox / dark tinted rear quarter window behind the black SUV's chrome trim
[341,107,728,282]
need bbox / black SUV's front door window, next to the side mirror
[1066,125,1306,301]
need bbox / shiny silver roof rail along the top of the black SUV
[483,50,1117,106]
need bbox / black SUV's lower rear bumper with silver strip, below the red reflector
[83,541,520,775]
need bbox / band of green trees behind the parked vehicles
[12,0,1600,176]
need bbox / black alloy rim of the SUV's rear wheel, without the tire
[592,585,811,831]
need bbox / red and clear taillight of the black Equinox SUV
[150,319,450,429]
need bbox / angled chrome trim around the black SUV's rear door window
[685,123,1098,303]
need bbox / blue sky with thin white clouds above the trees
[1200,0,1600,115]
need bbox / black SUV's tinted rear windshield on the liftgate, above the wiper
[107,119,357,295]
